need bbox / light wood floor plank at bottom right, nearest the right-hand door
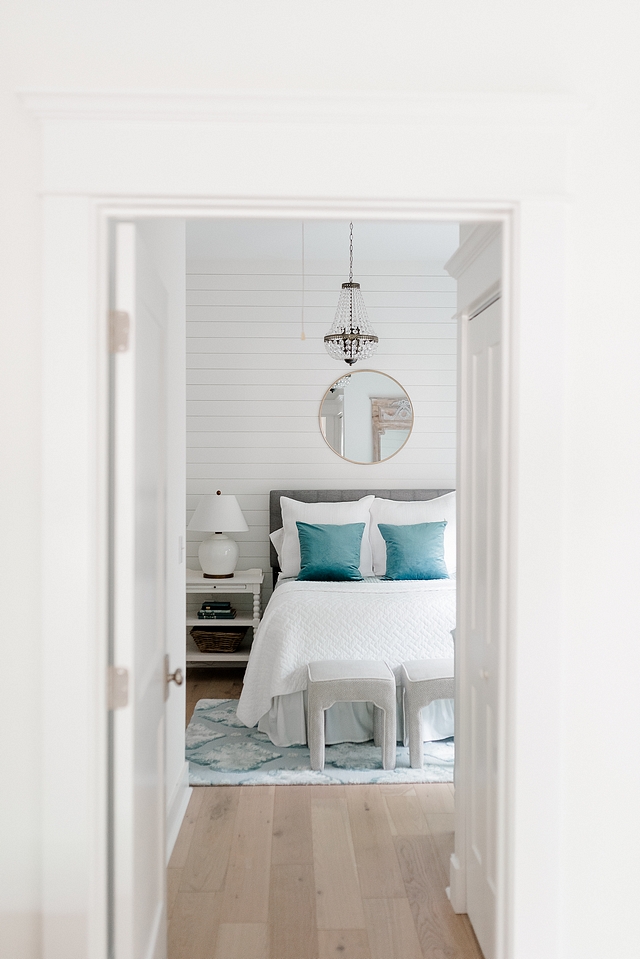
[394,836,482,959]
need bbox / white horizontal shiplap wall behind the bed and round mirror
[187,248,456,598]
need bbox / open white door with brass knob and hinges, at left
[110,223,167,959]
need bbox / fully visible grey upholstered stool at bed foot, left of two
[307,659,396,769]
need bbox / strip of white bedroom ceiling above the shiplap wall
[187,220,459,262]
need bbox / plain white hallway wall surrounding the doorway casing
[0,0,640,959]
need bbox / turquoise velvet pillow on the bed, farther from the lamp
[378,520,449,579]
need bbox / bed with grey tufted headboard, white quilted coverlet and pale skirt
[238,489,456,746]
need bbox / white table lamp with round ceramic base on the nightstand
[187,490,249,579]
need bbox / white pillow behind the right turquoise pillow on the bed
[370,490,456,576]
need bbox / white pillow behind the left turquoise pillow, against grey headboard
[274,496,382,577]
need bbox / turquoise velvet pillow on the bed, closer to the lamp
[296,522,365,582]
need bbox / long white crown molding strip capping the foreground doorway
[18,90,587,127]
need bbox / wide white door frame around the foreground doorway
[27,86,570,959]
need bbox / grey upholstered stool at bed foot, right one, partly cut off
[402,659,454,769]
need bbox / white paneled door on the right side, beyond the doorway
[459,299,503,959]
